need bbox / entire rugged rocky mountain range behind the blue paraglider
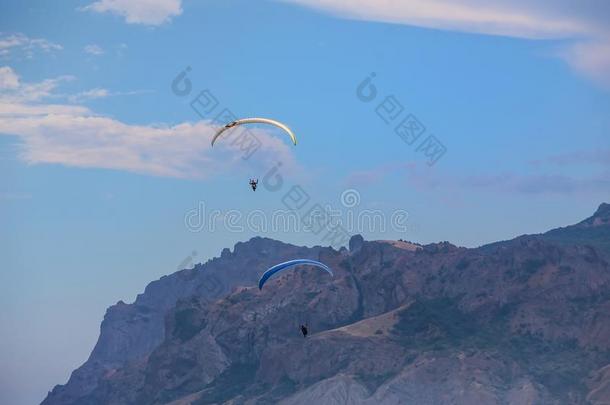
[43,204,610,405]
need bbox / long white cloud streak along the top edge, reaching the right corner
[283,0,610,87]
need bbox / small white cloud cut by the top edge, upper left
[84,0,182,25]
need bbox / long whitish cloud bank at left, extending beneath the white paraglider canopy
[0,68,296,178]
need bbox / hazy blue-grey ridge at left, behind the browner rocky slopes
[43,238,328,405]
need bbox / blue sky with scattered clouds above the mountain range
[0,0,610,405]
